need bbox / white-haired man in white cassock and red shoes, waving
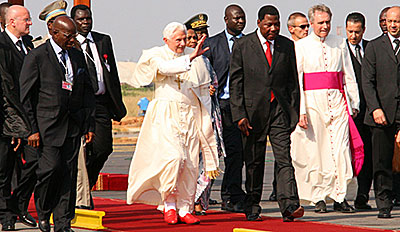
[127,22,218,224]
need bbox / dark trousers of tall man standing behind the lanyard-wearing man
[86,94,113,188]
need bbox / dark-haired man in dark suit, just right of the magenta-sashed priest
[346,12,372,210]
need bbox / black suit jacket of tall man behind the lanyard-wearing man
[91,31,126,121]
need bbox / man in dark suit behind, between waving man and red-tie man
[204,5,246,212]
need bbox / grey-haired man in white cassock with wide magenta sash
[291,5,359,213]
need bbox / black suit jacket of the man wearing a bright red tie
[229,32,300,132]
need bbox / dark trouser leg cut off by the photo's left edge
[0,136,16,223]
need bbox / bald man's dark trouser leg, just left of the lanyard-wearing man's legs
[11,142,40,214]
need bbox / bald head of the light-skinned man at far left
[6,5,32,38]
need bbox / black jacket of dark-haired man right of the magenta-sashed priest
[346,39,369,124]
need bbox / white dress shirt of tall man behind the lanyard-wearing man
[76,32,106,95]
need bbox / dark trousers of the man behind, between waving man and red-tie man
[219,99,245,204]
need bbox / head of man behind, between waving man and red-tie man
[224,4,246,36]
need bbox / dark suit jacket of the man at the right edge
[361,35,400,127]
